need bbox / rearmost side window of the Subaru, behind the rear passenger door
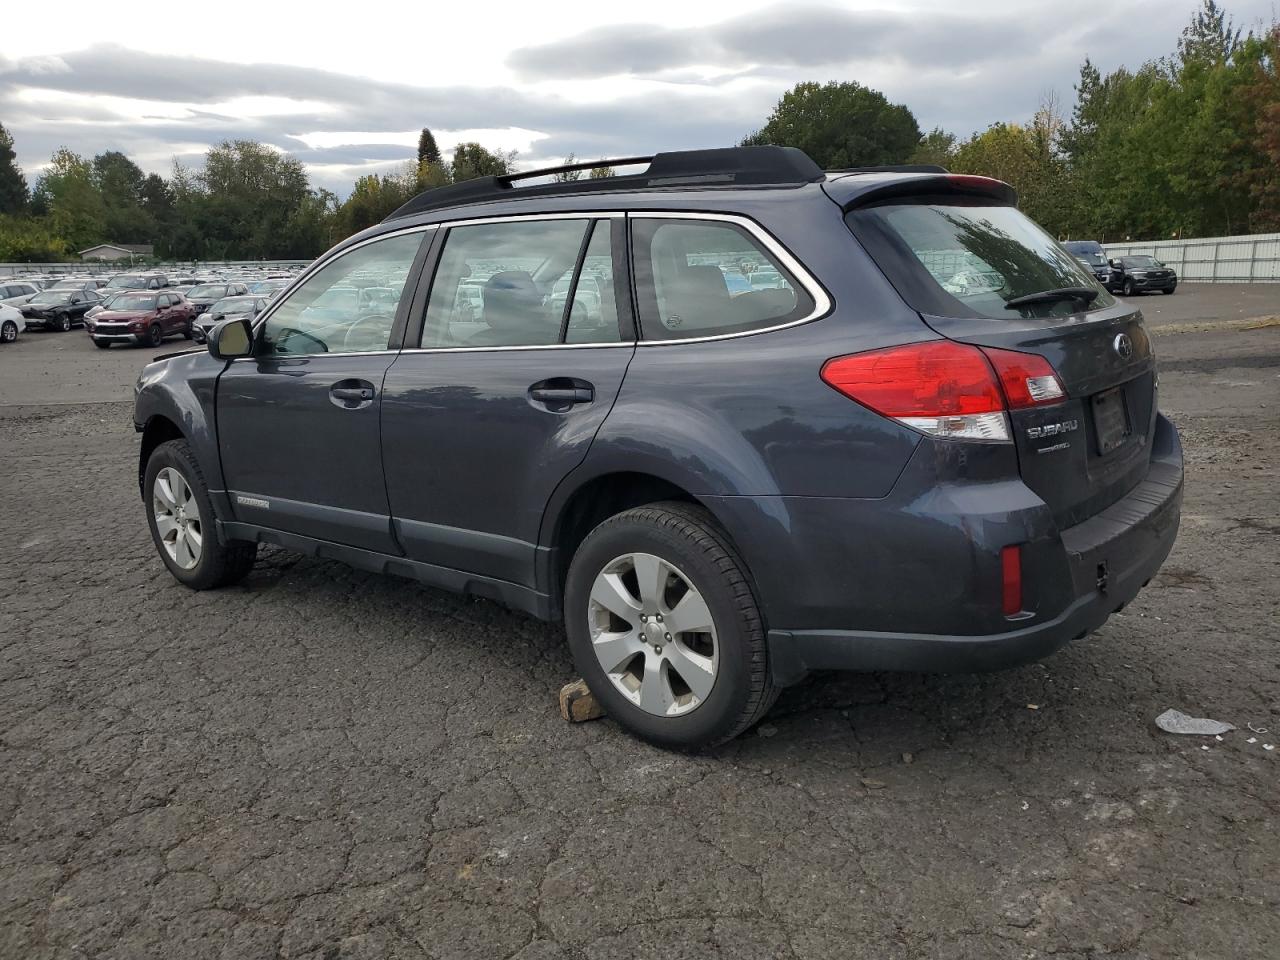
[631,218,814,340]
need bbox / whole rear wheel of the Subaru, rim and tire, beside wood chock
[564,502,777,749]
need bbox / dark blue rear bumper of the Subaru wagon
[711,416,1183,685]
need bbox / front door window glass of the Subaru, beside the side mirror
[257,232,424,357]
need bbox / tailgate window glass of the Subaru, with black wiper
[847,197,1115,320]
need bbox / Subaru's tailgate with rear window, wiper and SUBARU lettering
[847,193,1156,527]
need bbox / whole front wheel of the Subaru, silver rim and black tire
[142,440,257,590]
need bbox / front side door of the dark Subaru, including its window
[216,230,428,553]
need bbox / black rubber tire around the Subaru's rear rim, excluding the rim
[564,502,778,750]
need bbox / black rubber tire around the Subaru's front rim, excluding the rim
[142,440,257,590]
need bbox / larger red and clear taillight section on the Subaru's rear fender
[822,340,1009,442]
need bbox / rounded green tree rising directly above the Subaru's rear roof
[742,81,920,170]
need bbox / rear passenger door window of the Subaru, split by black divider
[420,219,620,348]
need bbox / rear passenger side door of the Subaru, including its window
[383,214,635,589]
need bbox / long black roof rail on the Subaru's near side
[384,146,826,223]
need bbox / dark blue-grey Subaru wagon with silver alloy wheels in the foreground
[134,147,1183,746]
